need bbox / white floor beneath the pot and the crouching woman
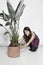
[0,47,43,65]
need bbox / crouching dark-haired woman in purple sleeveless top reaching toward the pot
[18,27,39,52]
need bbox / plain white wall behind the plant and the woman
[0,0,43,45]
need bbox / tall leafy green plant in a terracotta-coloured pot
[0,0,25,58]
